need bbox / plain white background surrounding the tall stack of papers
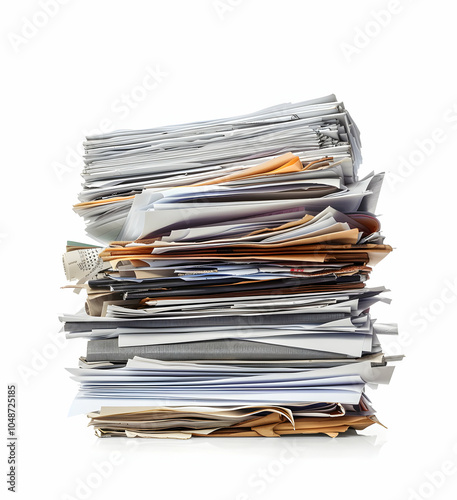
[0,0,457,500]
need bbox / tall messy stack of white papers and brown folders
[61,96,401,439]
